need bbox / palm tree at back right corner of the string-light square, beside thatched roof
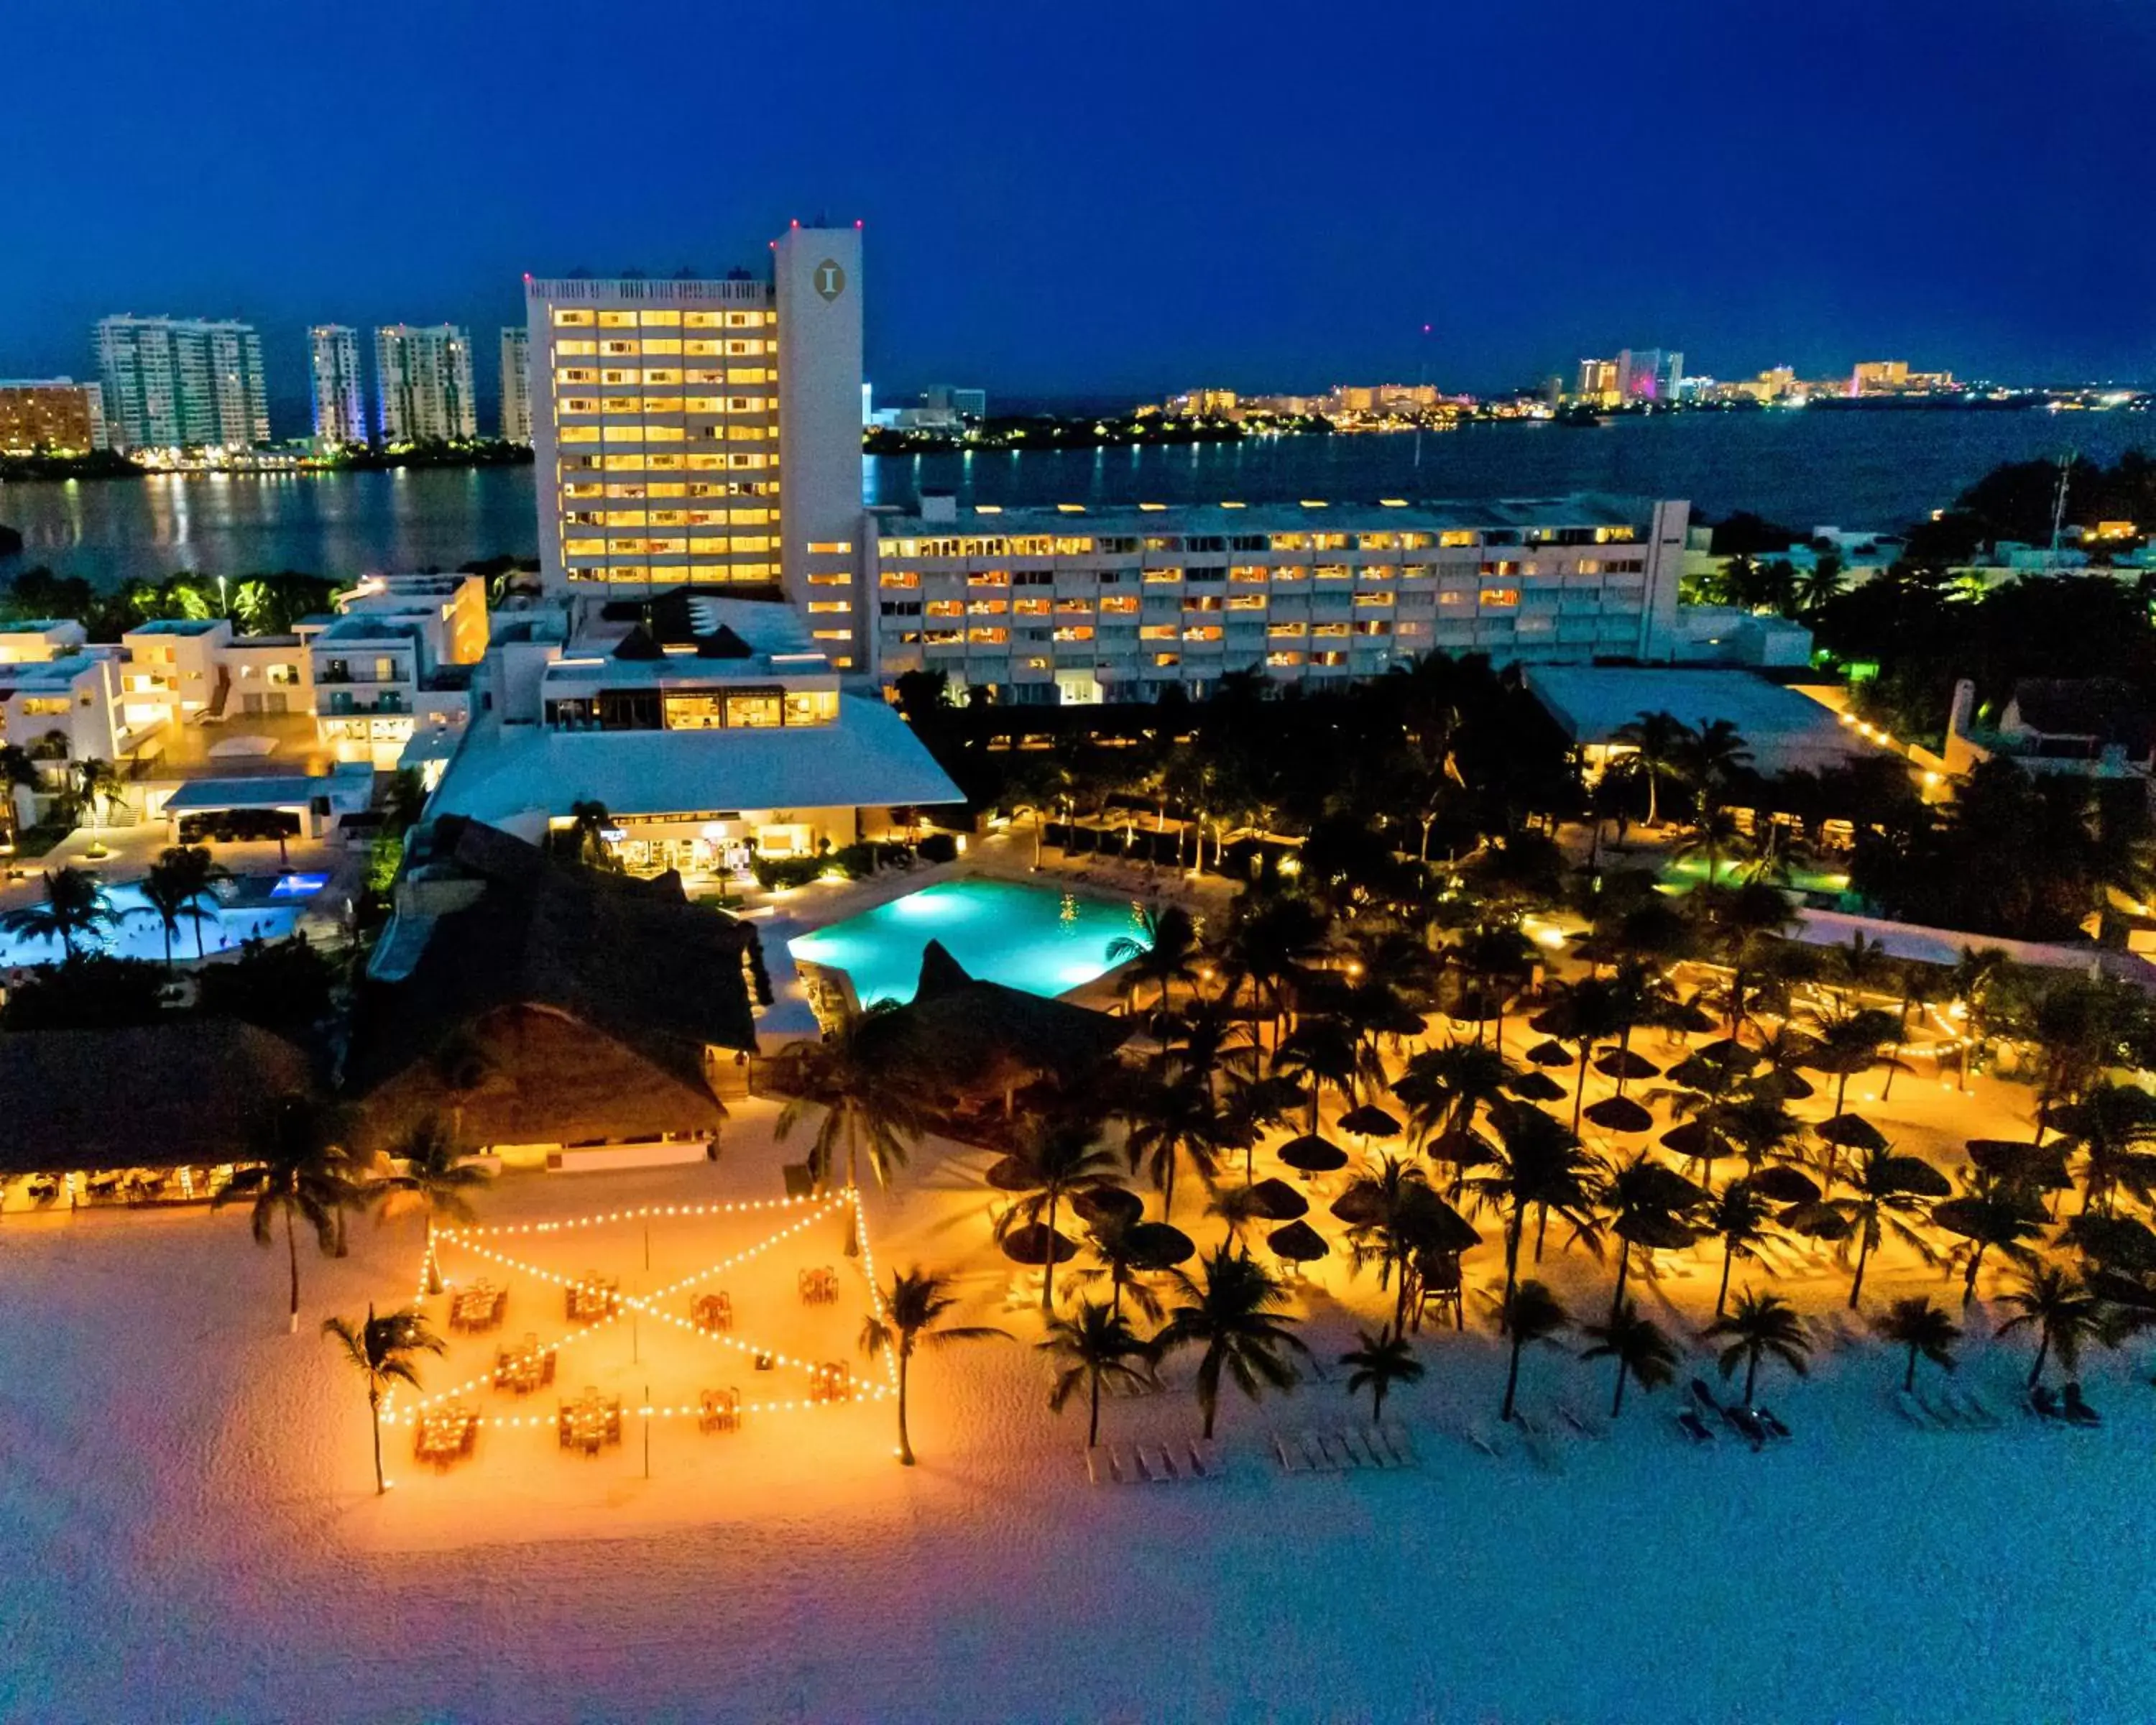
[772,1000,927,1225]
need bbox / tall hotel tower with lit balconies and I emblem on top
[524,226,865,671]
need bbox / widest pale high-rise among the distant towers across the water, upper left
[95,317,270,448]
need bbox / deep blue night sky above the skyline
[0,0,2156,431]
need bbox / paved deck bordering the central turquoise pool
[742,828,1235,1052]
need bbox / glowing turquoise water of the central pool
[787,880,1138,1007]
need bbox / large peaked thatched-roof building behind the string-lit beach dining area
[345,815,757,1167]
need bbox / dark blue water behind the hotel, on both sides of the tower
[0,410,2156,582]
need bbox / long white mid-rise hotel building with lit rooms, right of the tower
[860,496,1688,703]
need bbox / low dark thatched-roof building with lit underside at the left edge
[0,1018,315,1210]
